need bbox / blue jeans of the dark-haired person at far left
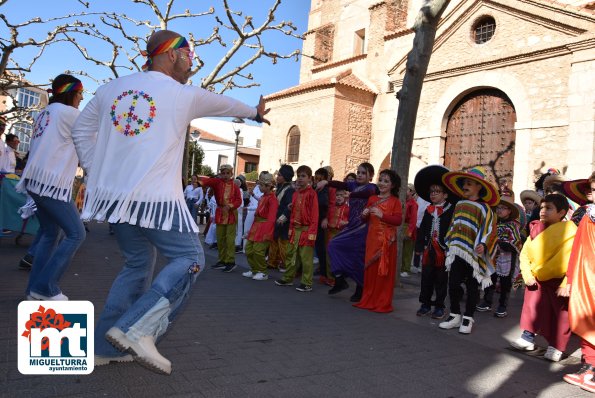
[26,192,86,296]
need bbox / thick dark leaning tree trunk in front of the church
[391,0,450,285]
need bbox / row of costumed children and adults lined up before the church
[188,163,595,392]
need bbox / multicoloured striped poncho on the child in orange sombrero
[445,200,498,288]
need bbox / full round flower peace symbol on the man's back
[110,90,157,136]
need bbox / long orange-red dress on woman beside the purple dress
[354,195,403,312]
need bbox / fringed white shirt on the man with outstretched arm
[72,71,256,232]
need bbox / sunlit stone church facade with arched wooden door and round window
[260,0,595,192]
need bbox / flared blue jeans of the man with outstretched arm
[95,218,205,357]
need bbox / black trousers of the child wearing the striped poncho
[448,256,479,317]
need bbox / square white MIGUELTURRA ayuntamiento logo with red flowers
[18,301,95,374]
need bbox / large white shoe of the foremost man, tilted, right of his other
[105,327,171,375]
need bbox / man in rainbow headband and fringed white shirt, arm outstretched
[73,30,267,374]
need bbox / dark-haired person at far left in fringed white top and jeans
[16,75,85,300]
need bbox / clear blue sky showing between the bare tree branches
[0,0,310,104]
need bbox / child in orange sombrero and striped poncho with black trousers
[438,167,500,334]
